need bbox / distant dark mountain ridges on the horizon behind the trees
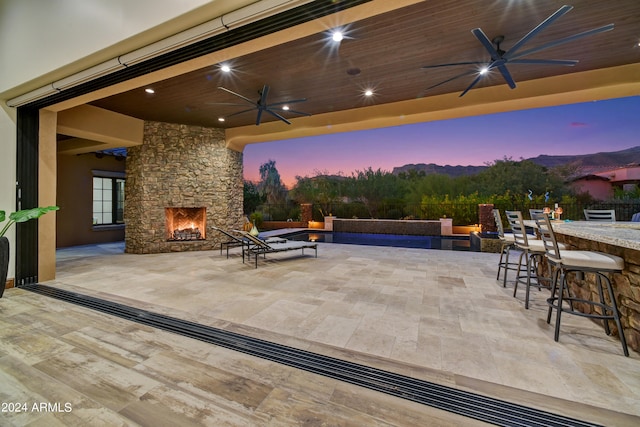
[392,146,640,177]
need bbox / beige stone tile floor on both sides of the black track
[0,243,640,425]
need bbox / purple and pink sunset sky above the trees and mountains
[244,96,640,187]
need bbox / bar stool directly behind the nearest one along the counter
[505,211,551,309]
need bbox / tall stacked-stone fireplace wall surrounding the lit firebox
[124,122,243,254]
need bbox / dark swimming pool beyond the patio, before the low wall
[282,230,470,251]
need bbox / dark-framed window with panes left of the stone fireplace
[93,176,124,225]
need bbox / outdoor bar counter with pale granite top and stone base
[553,221,640,352]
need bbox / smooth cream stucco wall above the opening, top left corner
[0,0,220,93]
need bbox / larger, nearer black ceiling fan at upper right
[422,5,613,97]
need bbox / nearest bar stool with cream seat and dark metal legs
[535,215,629,357]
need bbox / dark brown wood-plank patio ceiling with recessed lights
[86,0,640,136]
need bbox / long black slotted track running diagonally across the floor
[21,284,598,427]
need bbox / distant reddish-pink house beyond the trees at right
[571,164,640,200]
